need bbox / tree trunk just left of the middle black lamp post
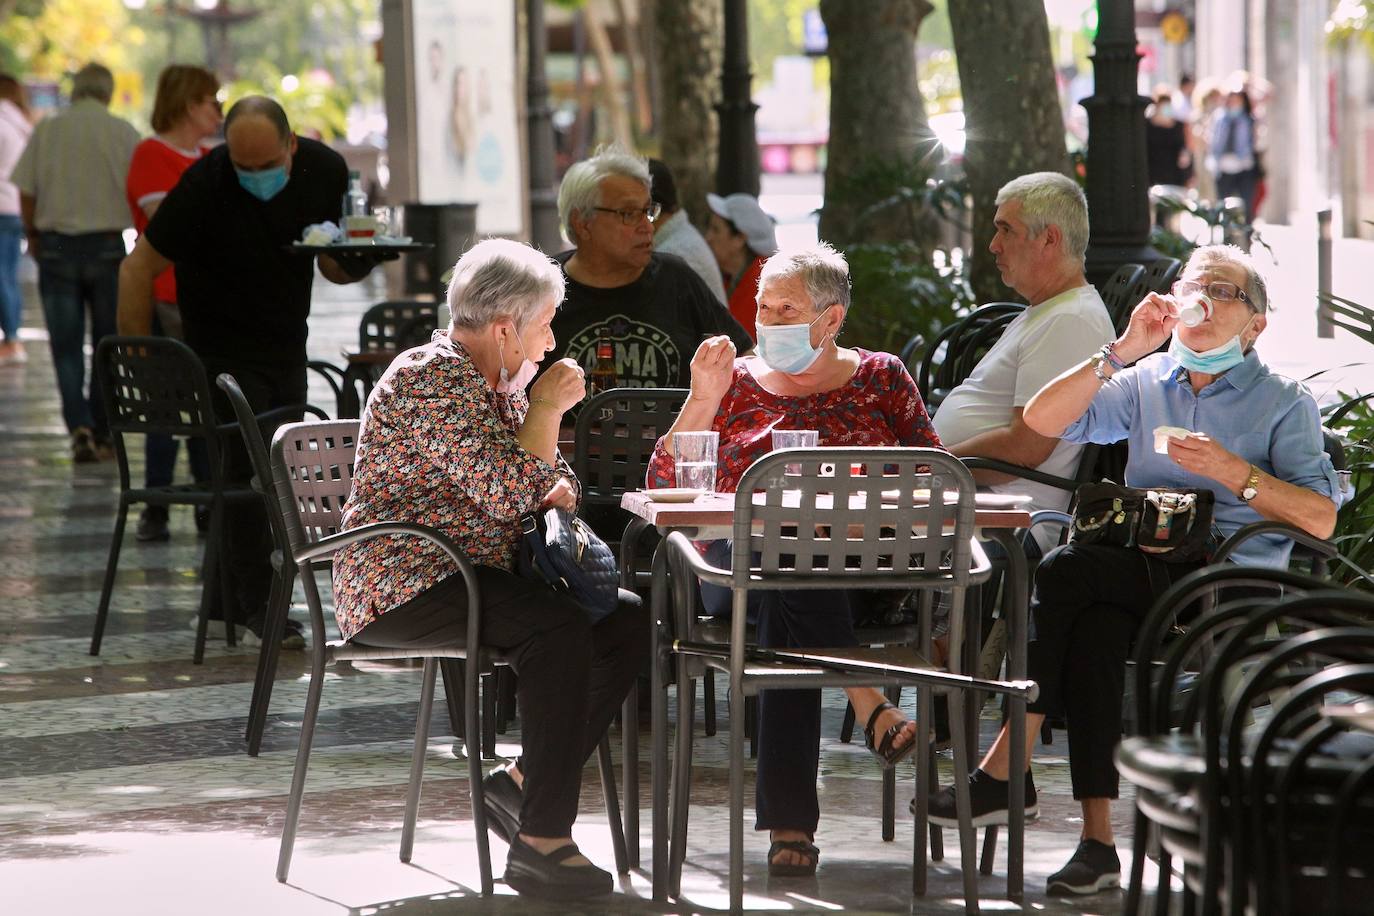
[654,0,724,225]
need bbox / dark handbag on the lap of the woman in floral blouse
[517,508,620,623]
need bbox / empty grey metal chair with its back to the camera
[655,448,1025,912]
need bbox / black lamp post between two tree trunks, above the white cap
[716,0,758,196]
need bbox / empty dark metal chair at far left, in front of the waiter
[91,335,270,665]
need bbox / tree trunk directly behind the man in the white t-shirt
[949,0,1070,302]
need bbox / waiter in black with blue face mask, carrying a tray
[118,96,396,648]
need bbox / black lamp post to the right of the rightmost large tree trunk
[1083,0,1160,286]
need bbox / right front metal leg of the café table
[985,529,1031,904]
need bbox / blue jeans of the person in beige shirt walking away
[38,232,124,435]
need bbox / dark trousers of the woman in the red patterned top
[701,541,871,834]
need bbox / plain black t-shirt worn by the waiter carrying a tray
[144,137,348,365]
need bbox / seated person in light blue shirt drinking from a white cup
[930,244,1341,894]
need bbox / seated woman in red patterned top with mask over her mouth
[649,243,940,875]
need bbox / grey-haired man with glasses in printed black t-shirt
[548,147,753,389]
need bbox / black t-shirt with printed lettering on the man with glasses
[543,251,754,389]
